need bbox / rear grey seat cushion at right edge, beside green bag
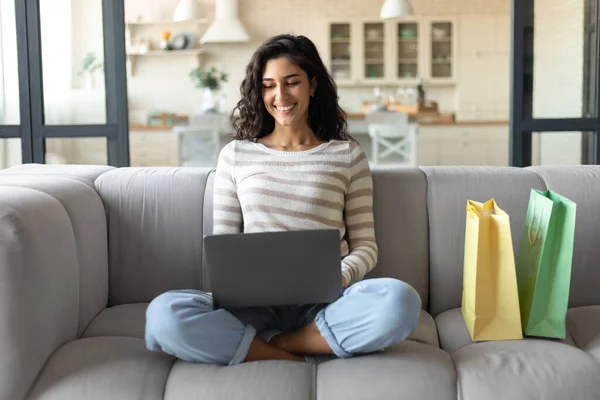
[567,306,600,360]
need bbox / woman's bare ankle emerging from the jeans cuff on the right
[269,321,334,354]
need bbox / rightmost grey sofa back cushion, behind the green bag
[528,165,600,307]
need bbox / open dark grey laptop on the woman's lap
[204,229,343,308]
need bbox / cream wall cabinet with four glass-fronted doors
[323,17,457,87]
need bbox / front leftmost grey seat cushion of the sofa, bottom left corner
[27,337,175,400]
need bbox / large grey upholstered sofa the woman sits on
[0,165,600,400]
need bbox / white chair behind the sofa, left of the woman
[173,113,229,167]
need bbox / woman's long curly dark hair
[231,34,354,141]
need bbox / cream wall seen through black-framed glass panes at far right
[533,0,584,165]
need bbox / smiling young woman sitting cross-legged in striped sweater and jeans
[146,35,421,365]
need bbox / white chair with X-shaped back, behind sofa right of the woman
[365,111,418,165]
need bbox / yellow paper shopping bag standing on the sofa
[461,199,523,341]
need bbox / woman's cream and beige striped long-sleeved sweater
[213,140,377,284]
